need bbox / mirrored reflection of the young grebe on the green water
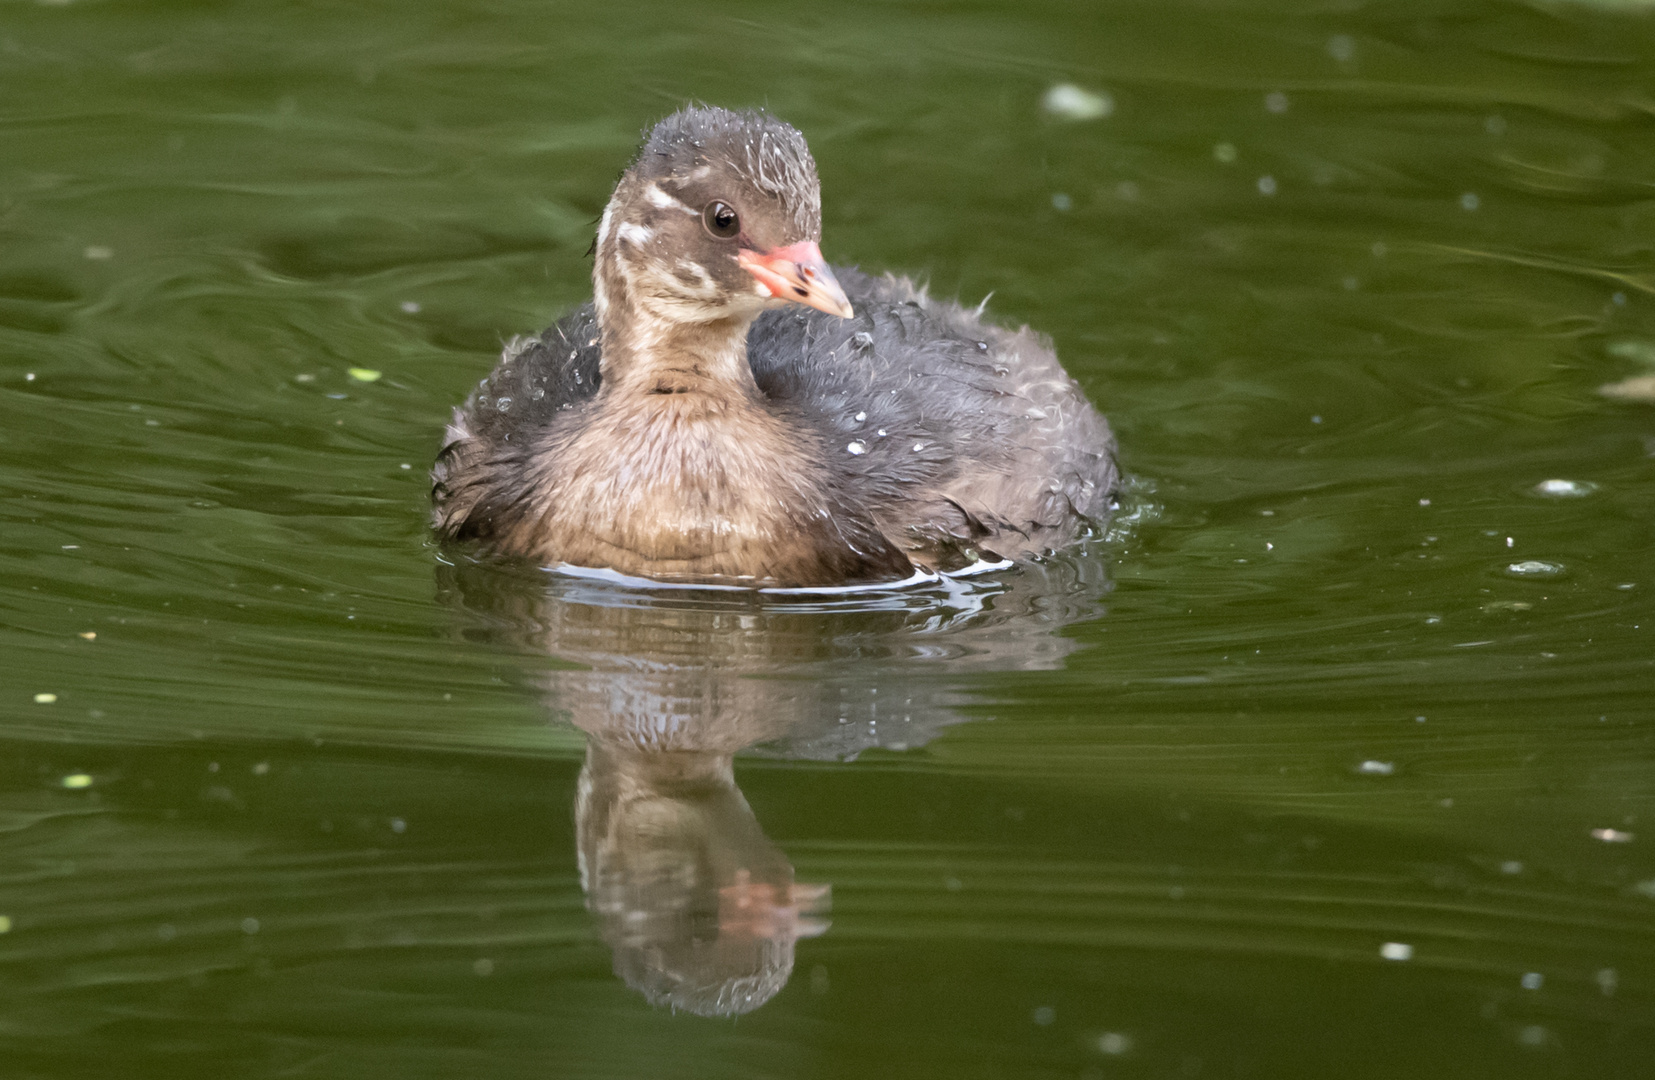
[444,556,1104,1015]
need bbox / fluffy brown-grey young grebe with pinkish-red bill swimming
[432,108,1117,587]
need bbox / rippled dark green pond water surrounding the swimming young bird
[0,0,1655,1080]
